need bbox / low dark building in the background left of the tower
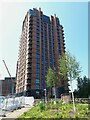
[0,77,16,96]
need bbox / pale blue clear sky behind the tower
[0,2,88,89]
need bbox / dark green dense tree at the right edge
[75,76,90,98]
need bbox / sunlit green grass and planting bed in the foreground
[17,101,90,120]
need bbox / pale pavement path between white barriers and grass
[0,106,31,120]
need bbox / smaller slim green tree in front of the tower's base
[46,68,58,104]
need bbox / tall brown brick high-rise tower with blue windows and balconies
[16,8,67,97]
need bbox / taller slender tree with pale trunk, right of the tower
[59,51,81,112]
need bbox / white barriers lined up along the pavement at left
[0,96,34,116]
